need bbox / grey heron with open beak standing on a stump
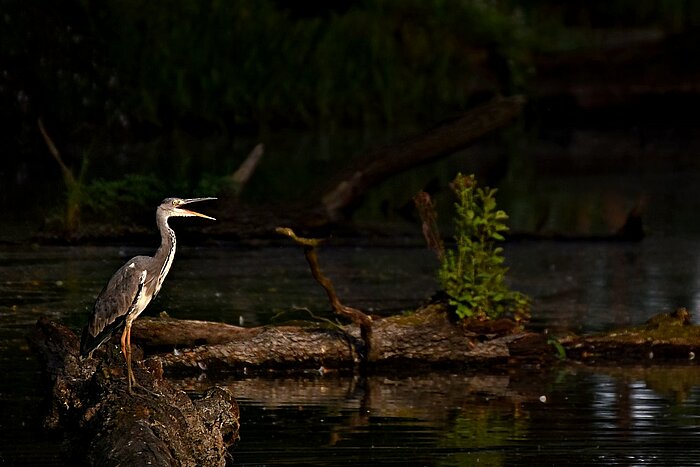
[80,198,216,392]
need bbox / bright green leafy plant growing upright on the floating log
[438,174,530,320]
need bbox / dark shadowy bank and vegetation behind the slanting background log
[0,0,700,235]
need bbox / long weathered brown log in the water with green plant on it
[132,304,553,373]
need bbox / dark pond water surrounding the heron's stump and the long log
[0,237,700,465]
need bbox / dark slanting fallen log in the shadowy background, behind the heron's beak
[201,96,525,239]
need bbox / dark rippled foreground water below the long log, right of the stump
[172,366,700,466]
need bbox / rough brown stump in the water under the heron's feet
[31,319,238,466]
